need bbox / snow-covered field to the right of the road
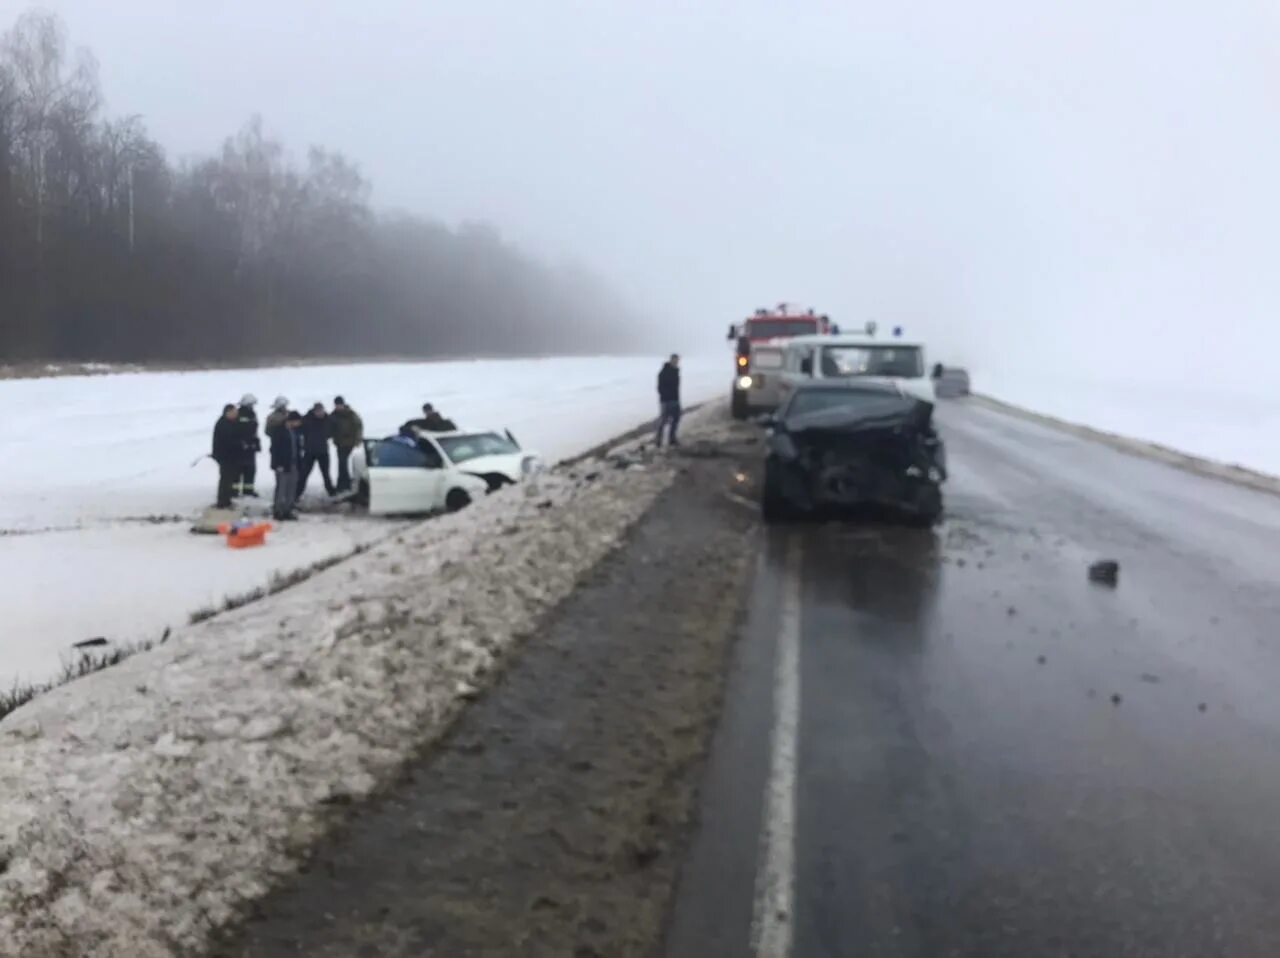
[973,369,1280,475]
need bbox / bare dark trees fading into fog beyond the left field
[0,12,639,362]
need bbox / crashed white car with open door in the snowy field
[351,429,543,516]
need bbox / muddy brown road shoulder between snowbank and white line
[218,444,758,958]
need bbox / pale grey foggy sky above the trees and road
[0,0,1280,386]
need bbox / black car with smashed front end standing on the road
[762,382,947,525]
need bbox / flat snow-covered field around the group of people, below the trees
[0,356,728,686]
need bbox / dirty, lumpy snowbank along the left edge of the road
[0,412,717,958]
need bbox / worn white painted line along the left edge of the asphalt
[751,534,803,958]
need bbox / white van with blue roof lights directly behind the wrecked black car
[778,333,936,402]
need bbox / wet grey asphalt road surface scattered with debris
[667,403,1280,958]
